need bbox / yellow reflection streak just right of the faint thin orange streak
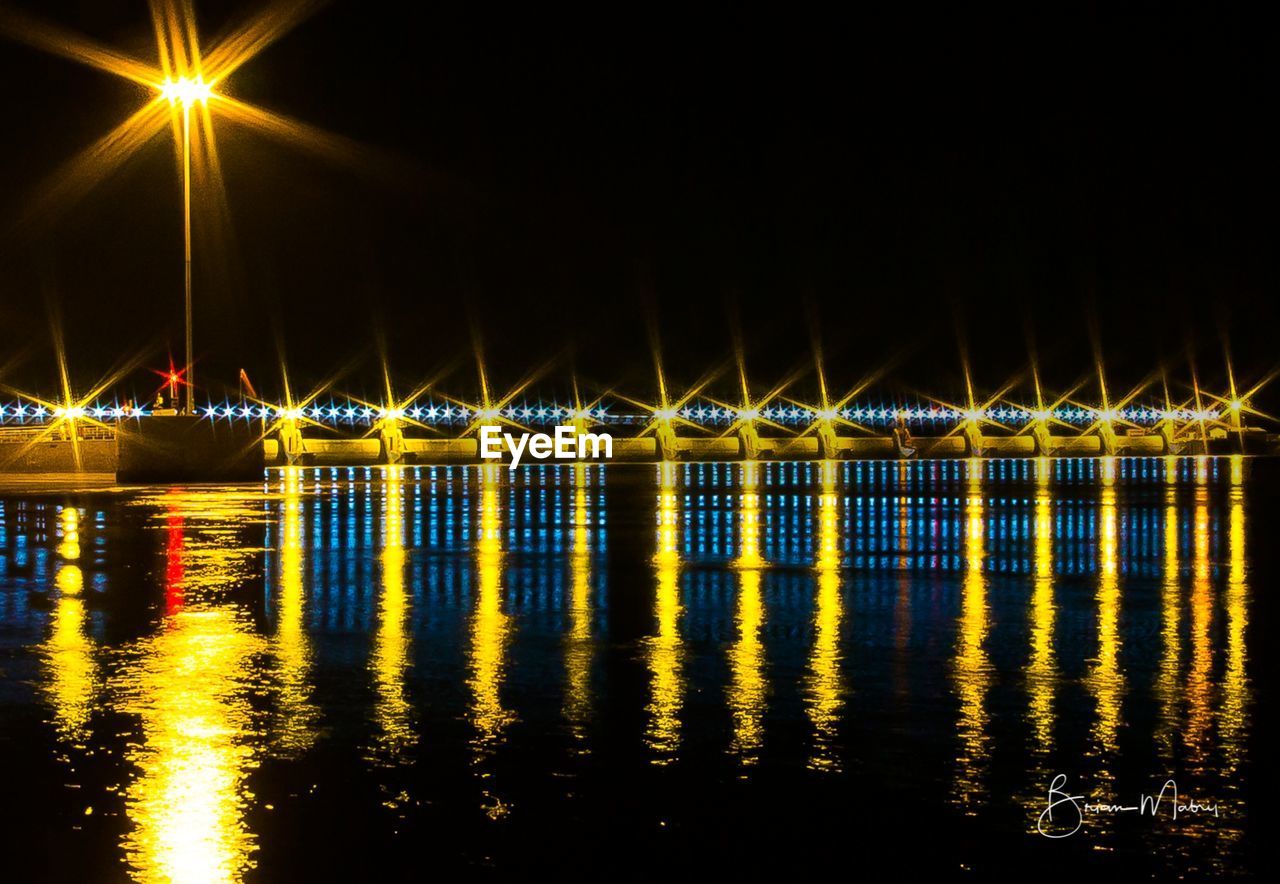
[952,459,991,815]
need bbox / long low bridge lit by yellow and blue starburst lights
[0,384,1280,472]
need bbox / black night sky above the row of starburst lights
[0,1,1277,406]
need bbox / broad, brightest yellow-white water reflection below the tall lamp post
[116,493,268,881]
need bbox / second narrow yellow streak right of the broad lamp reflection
[369,466,417,764]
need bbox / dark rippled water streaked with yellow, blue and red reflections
[0,458,1259,880]
